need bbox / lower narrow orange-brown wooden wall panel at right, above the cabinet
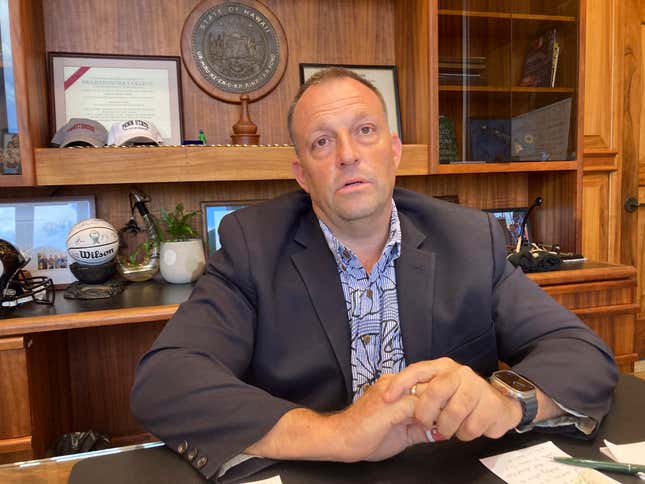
[582,173,610,262]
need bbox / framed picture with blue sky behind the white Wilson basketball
[0,196,95,285]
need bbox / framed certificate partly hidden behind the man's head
[300,64,403,141]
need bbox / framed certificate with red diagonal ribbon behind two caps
[49,52,183,145]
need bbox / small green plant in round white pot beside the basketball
[158,203,206,284]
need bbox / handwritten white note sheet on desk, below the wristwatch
[480,441,618,484]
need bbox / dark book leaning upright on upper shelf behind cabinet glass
[520,29,560,87]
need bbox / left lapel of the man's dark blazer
[291,211,352,403]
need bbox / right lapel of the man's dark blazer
[395,212,436,365]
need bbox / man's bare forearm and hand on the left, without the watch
[245,375,428,462]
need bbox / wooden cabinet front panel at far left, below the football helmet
[0,337,31,440]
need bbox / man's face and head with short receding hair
[293,78,401,233]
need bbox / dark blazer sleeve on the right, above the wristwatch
[489,216,618,422]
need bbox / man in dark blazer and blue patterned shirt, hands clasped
[132,69,617,478]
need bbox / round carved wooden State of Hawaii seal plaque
[181,0,287,103]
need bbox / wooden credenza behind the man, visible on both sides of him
[0,263,638,463]
